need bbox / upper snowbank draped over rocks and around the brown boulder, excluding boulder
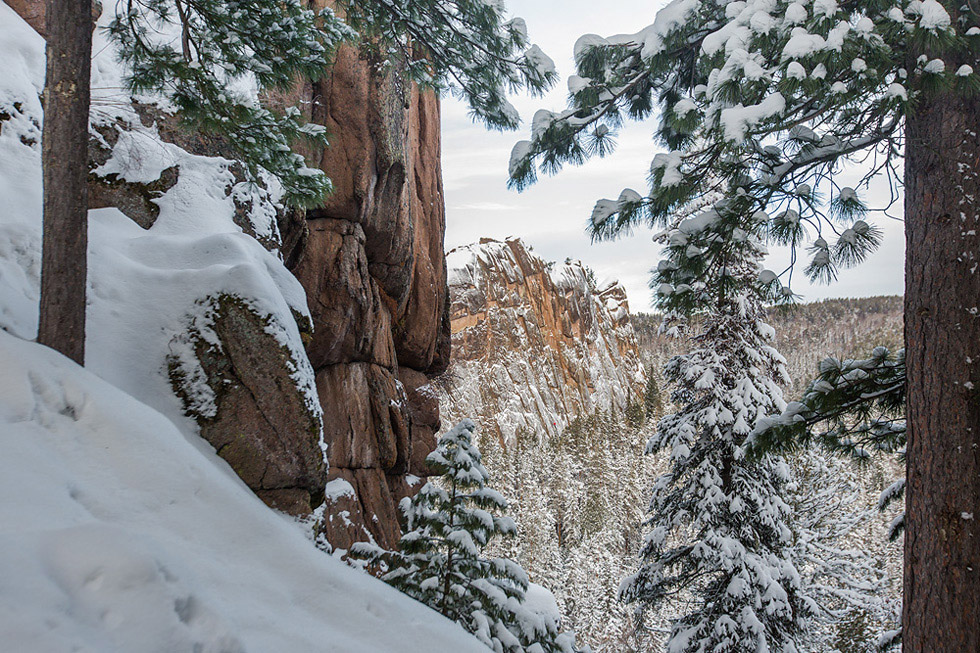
[0,3,316,428]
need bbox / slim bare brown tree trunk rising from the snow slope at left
[37,0,92,364]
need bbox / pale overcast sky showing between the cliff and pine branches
[442,0,905,311]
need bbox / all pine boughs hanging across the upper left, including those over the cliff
[108,0,556,207]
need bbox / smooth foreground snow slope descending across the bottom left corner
[0,331,483,653]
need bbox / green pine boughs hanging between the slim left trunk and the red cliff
[109,0,354,206]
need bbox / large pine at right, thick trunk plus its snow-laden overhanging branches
[510,0,980,640]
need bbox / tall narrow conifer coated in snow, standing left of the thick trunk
[621,215,813,653]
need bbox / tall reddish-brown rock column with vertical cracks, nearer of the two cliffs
[293,43,450,549]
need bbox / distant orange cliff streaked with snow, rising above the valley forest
[443,239,645,446]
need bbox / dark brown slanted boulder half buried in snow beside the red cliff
[169,295,327,515]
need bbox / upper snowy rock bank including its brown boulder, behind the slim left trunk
[0,4,326,513]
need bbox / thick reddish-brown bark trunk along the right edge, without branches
[902,75,980,653]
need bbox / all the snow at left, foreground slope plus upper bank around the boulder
[0,2,485,653]
